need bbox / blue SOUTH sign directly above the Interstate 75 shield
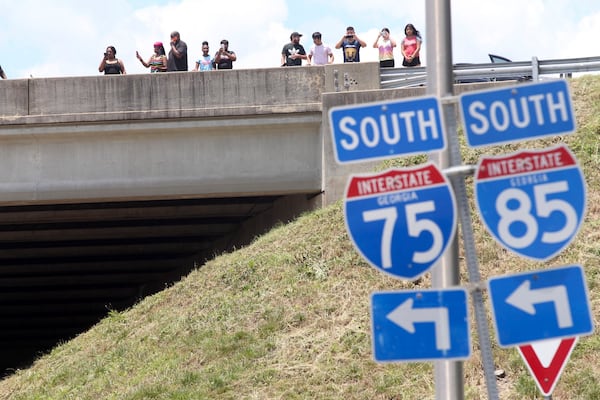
[329,97,446,164]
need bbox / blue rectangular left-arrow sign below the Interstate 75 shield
[371,289,471,362]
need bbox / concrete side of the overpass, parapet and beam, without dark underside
[0,63,508,204]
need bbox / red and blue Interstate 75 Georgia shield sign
[344,162,456,279]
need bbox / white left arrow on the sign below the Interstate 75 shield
[386,298,450,350]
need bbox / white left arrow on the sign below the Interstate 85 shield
[506,280,573,328]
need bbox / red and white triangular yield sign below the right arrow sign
[518,337,579,396]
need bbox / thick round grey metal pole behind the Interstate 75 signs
[425,0,464,400]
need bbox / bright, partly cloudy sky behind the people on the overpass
[0,0,600,79]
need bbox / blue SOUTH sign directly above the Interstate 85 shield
[460,80,575,147]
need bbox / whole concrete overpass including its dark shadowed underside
[0,63,488,371]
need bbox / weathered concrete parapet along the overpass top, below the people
[0,63,379,126]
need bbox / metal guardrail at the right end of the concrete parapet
[380,57,600,89]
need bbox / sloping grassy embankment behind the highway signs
[0,76,600,400]
